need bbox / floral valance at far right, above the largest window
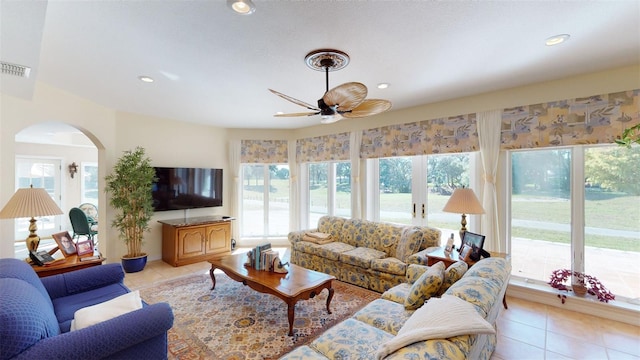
[501,89,640,150]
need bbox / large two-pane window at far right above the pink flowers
[511,145,640,298]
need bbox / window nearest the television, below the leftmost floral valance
[242,164,289,238]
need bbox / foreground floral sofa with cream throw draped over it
[281,258,511,360]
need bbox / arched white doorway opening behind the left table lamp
[13,122,100,259]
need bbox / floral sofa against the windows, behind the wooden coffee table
[289,216,441,293]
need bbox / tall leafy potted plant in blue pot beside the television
[105,146,156,272]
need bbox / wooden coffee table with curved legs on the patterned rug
[209,254,335,336]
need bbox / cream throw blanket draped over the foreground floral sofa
[376,295,495,359]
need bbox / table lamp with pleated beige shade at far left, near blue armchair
[0,185,63,251]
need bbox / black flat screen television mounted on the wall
[152,167,222,211]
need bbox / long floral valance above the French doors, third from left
[360,114,479,158]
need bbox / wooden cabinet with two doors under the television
[158,216,233,266]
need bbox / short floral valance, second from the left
[296,133,349,163]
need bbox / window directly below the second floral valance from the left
[307,161,351,227]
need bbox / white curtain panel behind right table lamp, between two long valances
[477,110,504,252]
